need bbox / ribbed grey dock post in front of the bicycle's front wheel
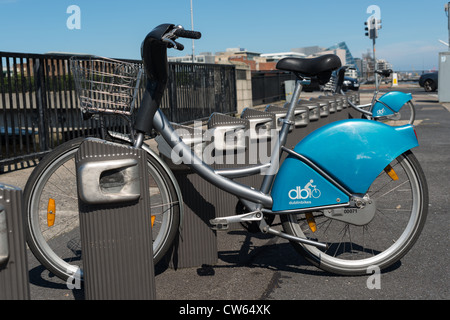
[74,139,156,300]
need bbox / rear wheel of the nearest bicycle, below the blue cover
[281,151,428,275]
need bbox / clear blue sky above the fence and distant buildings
[0,0,448,70]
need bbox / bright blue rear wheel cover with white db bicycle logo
[272,119,418,211]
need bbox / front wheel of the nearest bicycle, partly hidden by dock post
[24,138,180,280]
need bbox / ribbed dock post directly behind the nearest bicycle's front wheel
[156,123,217,269]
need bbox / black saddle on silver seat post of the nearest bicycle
[277,54,341,84]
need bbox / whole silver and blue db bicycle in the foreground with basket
[25,24,428,279]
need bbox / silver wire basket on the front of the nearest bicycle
[70,57,143,116]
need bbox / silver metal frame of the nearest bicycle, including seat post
[151,80,342,249]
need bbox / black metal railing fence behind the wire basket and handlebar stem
[0,52,237,172]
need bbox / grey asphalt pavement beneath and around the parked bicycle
[0,87,450,302]
